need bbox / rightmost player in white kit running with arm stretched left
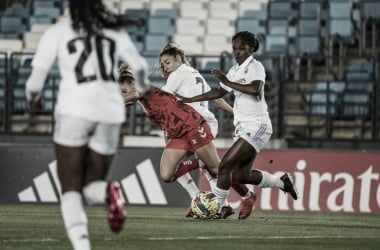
[178,31,297,219]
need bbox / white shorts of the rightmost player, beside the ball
[233,123,272,152]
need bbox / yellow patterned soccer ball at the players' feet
[191,191,219,219]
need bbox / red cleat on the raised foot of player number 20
[106,181,125,233]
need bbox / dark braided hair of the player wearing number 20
[69,0,127,35]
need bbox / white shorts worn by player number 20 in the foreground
[53,113,121,155]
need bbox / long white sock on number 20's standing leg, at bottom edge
[61,191,91,250]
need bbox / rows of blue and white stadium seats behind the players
[0,0,380,143]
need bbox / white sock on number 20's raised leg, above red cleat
[83,180,107,205]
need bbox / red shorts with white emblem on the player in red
[166,122,214,153]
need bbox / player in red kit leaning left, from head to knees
[119,65,220,186]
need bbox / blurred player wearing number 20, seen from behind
[26,0,148,250]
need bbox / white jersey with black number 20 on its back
[32,18,147,123]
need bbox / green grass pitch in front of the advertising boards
[0,205,380,250]
